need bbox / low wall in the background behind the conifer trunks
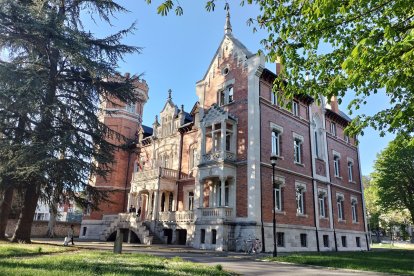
[6,219,80,237]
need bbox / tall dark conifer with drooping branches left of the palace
[0,0,139,242]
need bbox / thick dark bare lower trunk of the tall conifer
[12,184,40,243]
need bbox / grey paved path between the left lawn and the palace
[33,239,384,276]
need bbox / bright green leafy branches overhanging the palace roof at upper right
[152,0,414,135]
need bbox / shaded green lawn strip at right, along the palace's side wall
[269,246,414,275]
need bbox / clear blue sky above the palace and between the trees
[87,0,393,175]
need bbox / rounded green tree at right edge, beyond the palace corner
[372,134,414,223]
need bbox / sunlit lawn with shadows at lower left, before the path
[0,243,230,276]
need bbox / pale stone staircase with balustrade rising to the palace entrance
[100,214,165,245]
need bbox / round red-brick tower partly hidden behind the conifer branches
[84,73,149,220]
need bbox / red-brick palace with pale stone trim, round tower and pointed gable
[80,11,368,252]
